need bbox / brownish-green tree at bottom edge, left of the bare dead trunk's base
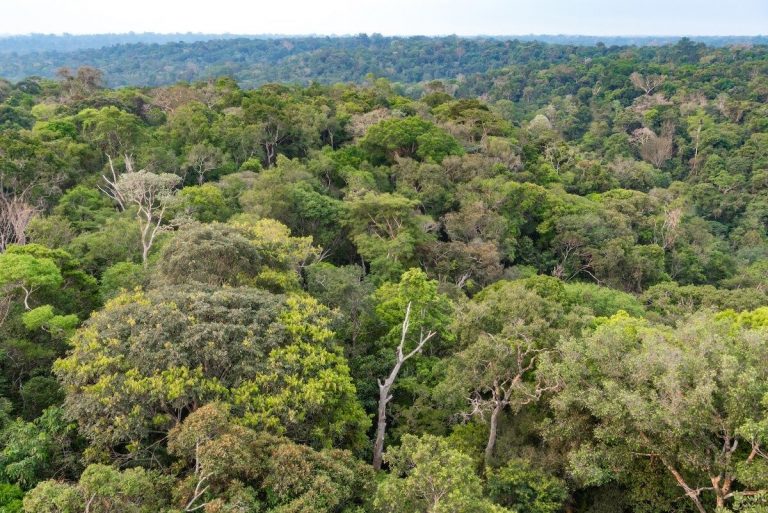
[168,403,374,513]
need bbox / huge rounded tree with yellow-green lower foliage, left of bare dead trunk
[54,286,367,457]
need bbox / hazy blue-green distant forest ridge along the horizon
[0,34,768,88]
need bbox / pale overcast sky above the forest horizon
[0,0,768,35]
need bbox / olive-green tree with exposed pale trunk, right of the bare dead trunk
[444,277,568,465]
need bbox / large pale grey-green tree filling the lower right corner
[548,309,768,513]
